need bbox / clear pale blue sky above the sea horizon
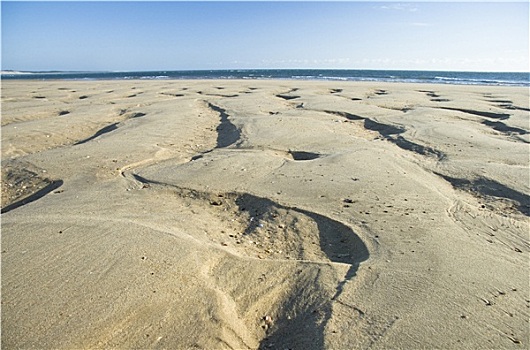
[1,1,530,72]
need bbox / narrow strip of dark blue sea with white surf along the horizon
[0,69,530,86]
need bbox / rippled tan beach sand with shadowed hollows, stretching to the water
[1,80,530,349]
